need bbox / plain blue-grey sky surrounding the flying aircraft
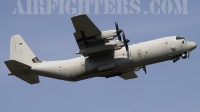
[0,0,200,112]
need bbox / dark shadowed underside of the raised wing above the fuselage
[71,14,108,55]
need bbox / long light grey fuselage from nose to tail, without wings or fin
[31,36,196,81]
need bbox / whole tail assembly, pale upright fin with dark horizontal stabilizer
[5,35,40,84]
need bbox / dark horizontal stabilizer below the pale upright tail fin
[5,60,39,84]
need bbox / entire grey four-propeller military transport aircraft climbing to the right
[5,14,197,84]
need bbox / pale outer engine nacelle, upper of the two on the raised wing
[95,30,117,40]
